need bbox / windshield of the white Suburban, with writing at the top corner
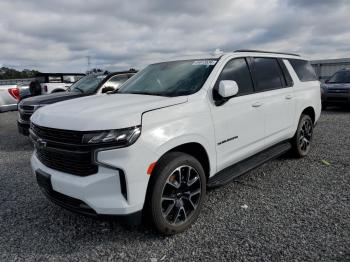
[118,59,217,96]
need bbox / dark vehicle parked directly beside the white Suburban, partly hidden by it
[17,71,135,135]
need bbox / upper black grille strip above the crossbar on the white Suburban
[31,124,83,145]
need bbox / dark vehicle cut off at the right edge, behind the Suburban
[321,69,350,109]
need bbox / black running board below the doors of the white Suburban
[208,142,292,187]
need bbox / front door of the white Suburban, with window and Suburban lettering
[211,58,264,171]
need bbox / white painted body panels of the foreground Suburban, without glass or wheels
[31,53,321,214]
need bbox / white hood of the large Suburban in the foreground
[31,94,187,131]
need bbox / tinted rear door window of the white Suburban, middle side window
[253,57,284,92]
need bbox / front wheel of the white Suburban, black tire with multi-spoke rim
[145,152,206,235]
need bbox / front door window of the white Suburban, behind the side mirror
[214,58,254,99]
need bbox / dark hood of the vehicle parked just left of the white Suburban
[21,92,88,106]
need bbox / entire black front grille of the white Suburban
[31,123,98,176]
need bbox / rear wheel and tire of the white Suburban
[292,114,314,158]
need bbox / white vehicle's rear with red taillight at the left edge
[0,85,20,113]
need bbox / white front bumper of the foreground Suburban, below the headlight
[31,141,157,215]
